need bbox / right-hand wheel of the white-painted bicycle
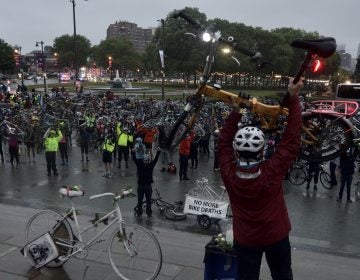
[108,224,162,280]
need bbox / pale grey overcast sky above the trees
[0,0,360,57]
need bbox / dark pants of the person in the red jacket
[234,237,293,280]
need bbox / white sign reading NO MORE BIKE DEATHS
[184,195,229,219]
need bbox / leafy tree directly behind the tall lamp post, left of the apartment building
[53,34,91,67]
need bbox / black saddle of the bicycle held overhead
[290,37,336,58]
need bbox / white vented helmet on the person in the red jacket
[233,126,265,153]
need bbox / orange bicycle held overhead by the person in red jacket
[167,11,346,161]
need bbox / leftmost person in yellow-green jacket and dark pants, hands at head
[44,129,62,176]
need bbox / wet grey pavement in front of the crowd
[0,143,360,280]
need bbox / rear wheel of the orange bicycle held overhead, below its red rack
[299,112,353,162]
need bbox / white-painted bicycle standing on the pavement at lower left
[24,187,162,280]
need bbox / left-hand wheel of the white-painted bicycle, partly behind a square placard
[25,210,74,267]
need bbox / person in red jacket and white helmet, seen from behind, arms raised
[218,79,302,280]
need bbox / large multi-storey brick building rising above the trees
[106,21,153,53]
